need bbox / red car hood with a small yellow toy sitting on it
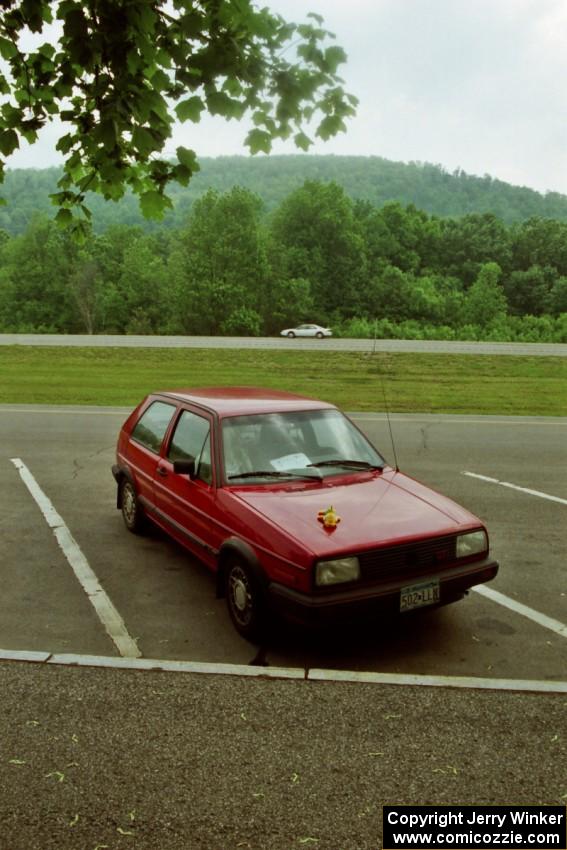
[233,470,482,557]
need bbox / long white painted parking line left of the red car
[11,457,141,658]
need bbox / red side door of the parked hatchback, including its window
[155,408,223,566]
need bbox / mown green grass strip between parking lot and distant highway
[0,345,567,416]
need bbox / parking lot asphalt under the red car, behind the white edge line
[0,406,567,680]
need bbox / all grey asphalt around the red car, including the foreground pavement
[0,405,567,850]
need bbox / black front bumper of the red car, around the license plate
[268,558,499,625]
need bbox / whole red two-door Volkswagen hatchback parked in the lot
[112,387,498,638]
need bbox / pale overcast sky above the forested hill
[8,0,567,194]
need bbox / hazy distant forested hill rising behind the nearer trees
[0,154,567,234]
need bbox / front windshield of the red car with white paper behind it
[222,410,385,484]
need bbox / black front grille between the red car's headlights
[358,536,462,582]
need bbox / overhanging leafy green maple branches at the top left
[0,0,356,229]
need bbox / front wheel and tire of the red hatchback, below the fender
[225,558,266,640]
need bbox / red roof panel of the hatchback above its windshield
[152,387,334,417]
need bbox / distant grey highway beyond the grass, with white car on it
[0,334,567,357]
